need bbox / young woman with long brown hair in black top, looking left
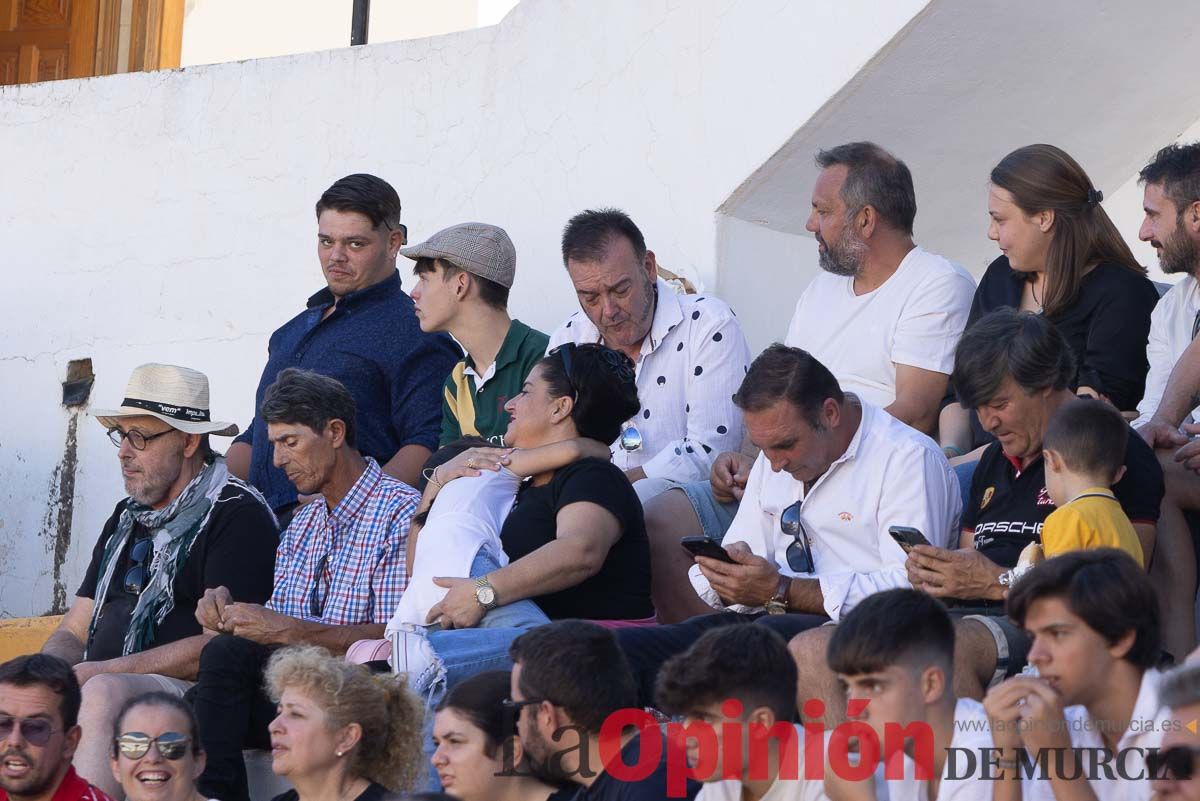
[938,145,1158,457]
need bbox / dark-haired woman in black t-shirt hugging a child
[431,343,654,623]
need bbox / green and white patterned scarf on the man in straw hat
[84,456,234,660]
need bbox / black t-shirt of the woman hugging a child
[500,459,654,620]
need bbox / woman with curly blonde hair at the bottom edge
[266,646,425,801]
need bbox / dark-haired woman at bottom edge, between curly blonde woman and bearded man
[430,670,556,801]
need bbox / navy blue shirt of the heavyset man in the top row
[235,271,462,508]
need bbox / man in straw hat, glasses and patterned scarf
[42,365,278,797]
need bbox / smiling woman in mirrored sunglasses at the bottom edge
[113,692,204,801]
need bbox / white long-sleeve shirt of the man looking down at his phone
[690,402,962,620]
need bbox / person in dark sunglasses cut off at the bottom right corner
[1146,663,1200,801]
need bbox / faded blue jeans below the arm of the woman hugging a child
[413,549,550,791]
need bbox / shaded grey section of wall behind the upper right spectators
[718,0,1200,338]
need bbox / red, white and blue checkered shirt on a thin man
[266,457,420,626]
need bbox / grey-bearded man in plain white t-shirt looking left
[646,141,974,622]
